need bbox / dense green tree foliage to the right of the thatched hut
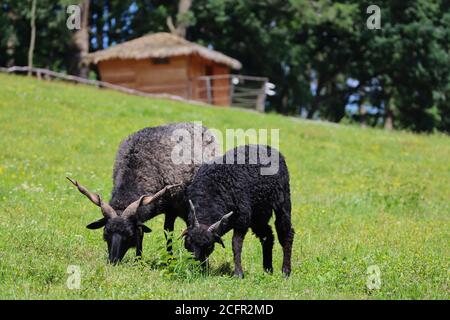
[189,0,450,131]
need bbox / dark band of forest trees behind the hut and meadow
[0,0,450,133]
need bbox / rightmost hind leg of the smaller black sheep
[275,205,294,277]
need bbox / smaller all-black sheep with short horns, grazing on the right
[182,145,294,277]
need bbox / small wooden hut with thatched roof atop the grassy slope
[86,32,241,106]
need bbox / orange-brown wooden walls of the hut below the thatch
[98,55,231,106]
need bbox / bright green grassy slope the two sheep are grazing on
[0,74,450,299]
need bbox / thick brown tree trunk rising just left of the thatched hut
[69,0,90,78]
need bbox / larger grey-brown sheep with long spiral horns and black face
[68,123,217,263]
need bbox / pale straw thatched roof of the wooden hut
[85,32,242,69]
